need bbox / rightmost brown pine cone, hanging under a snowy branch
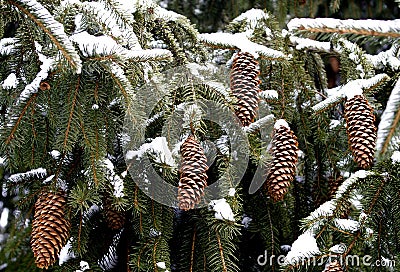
[345,95,377,169]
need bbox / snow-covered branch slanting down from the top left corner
[9,0,82,74]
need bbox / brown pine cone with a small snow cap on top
[266,119,298,201]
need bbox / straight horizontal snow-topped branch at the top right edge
[287,18,400,38]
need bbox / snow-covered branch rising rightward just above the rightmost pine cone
[312,74,389,111]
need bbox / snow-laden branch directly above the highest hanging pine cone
[199,33,287,59]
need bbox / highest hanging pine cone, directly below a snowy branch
[231,52,260,126]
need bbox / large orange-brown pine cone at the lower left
[31,191,70,269]
